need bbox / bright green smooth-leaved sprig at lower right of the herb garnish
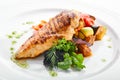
[58,52,85,70]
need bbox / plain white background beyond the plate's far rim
[0,0,120,14]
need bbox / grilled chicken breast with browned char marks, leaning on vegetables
[15,10,92,59]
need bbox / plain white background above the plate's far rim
[0,0,120,19]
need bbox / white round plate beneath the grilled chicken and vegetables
[0,0,119,80]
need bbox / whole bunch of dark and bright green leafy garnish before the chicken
[44,39,85,74]
